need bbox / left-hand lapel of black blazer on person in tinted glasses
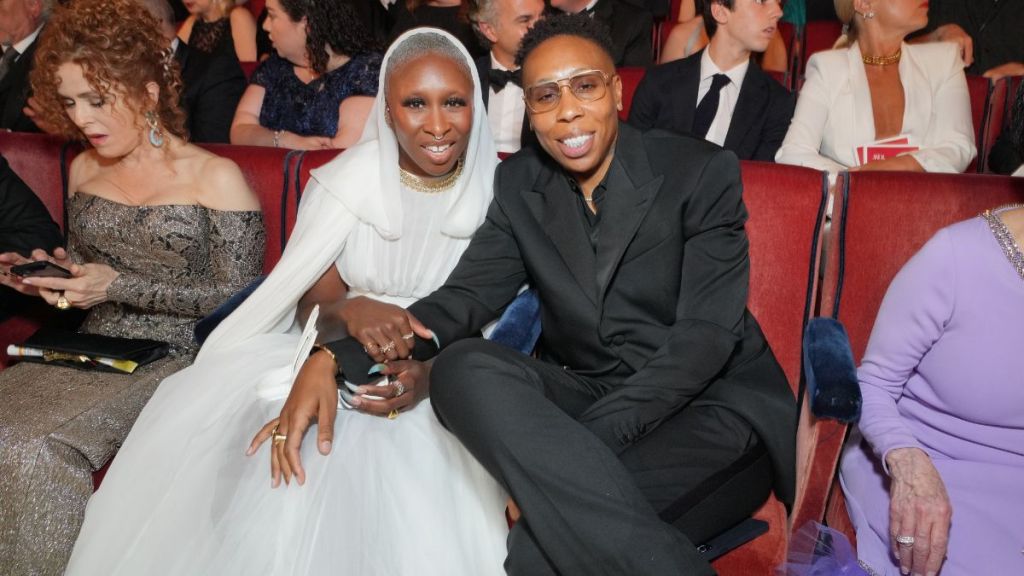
[524,160,603,305]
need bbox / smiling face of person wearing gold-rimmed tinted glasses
[522,36,623,191]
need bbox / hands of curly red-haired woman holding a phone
[0,248,118,308]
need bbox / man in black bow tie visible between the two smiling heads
[469,0,544,154]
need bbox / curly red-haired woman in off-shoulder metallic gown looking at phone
[0,0,264,575]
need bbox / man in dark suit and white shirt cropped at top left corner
[0,0,53,132]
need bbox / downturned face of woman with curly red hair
[57,63,144,158]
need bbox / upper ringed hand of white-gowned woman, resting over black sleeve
[339,296,433,362]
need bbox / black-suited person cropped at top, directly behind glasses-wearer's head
[551,0,654,68]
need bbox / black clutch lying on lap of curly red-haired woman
[13,328,169,374]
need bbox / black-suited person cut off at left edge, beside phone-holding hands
[0,156,63,321]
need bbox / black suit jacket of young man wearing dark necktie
[630,50,797,162]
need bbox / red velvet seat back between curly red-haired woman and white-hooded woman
[202,145,295,274]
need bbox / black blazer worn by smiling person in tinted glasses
[405,124,797,504]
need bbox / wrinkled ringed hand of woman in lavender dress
[886,448,952,574]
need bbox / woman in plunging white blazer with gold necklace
[775,0,977,173]
